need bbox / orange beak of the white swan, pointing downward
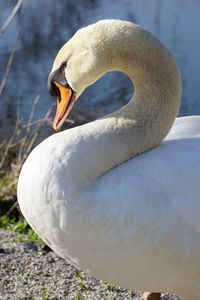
[53,81,76,131]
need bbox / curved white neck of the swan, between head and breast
[60,28,181,188]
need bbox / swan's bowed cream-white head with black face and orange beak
[48,20,136,130]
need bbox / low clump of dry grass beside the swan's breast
[0,95,53,215]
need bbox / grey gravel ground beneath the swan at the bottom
[0,229,184,300]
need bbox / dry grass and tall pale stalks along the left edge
[0,0,52,206]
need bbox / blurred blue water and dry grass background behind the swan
[0,0,200,213]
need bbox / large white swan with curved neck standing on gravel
[18,20,200,300]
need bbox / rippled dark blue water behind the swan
[0,0,200,130]
